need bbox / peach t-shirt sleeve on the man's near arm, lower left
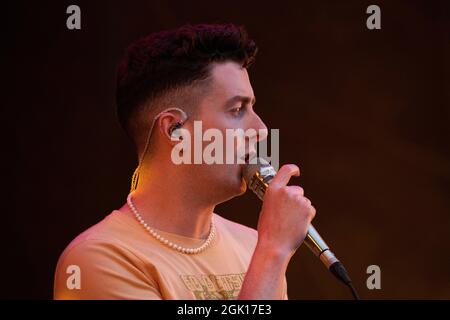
[54,240,162,300]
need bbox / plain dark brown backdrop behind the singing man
[0,1,450,299]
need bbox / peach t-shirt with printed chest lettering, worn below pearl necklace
[54,210,287,300]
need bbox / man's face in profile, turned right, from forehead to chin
[185,62,267,201]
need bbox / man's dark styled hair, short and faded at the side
[116,24,257,150]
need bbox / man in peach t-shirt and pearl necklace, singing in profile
[54,25,315,299]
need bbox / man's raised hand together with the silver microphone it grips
[244,158,359,299]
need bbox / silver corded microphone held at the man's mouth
[243,158,359,300]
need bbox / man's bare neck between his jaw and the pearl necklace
[123,161,215,239]
